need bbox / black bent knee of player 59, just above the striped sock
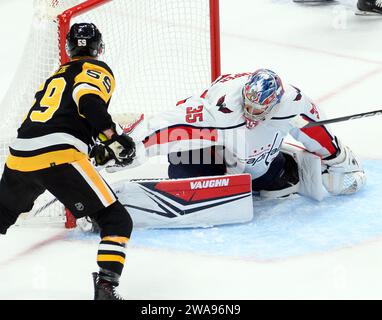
[91,201,133,238]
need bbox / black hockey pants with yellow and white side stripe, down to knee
[0,158,132,237]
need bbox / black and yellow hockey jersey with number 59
[6,59,115,171]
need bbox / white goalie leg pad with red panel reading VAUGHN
[112,174,253,228]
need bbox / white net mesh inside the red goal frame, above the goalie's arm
[73,0,210,117]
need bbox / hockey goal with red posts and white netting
[0,0,220,229]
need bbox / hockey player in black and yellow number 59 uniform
[0,23,135,300]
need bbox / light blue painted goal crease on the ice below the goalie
[70,160,382,261]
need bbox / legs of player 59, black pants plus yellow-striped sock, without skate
[0,158,133,285]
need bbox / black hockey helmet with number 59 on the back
[66,23,105,58]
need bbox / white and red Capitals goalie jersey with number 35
[127,73,339,179]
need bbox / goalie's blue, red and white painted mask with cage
[243,69,284,122]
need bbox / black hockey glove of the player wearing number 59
[89,133,135,167]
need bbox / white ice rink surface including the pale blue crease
[0,0,382,299]
